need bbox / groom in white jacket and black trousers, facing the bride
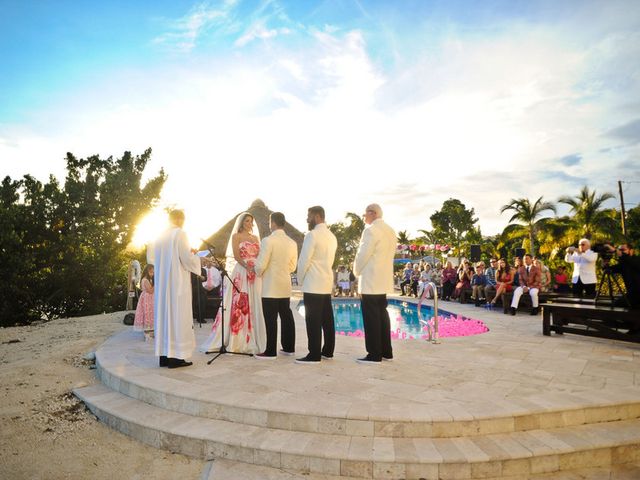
[255,212,298,359]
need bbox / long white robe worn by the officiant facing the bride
[153,228,200,359]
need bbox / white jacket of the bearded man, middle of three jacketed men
[298,223,338,295]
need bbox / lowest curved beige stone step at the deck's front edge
[74,385,640,479]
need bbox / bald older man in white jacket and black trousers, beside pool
[353,203,396,364]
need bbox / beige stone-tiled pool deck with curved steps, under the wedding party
[78,297,640,478]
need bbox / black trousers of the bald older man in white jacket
[361,294,393,361]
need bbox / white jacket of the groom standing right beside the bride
[255,228,298,298]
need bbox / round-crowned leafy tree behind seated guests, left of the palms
[430,198,479,257]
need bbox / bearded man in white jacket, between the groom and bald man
[296,206,338,365]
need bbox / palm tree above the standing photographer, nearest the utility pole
[558,185,617,239]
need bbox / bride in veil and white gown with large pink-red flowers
[200,212,267,354]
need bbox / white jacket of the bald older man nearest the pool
[353,218,396,295]
